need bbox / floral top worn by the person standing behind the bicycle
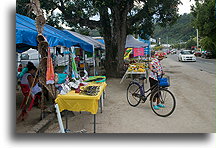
[149,58,163,81]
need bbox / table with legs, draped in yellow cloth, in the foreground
[55,82,107,133]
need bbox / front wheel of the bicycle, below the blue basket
[150,88,176,117]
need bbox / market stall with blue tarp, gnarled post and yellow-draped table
[16,9,106,132]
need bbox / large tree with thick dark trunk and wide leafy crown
[16,0,180,76]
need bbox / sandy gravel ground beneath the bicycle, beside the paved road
[45,58,216,133]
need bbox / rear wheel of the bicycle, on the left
[127,83,141,107]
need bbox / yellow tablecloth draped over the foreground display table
[55,82,107,114]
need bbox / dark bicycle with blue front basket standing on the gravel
[127,75,176,117]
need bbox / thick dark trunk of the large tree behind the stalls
[104,6,128,77]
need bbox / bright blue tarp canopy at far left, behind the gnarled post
[16,14,93,53]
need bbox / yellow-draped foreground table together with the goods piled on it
[55,48,107,133]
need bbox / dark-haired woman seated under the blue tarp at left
[21,65,42,105]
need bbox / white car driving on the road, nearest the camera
[178,50,196,62]
